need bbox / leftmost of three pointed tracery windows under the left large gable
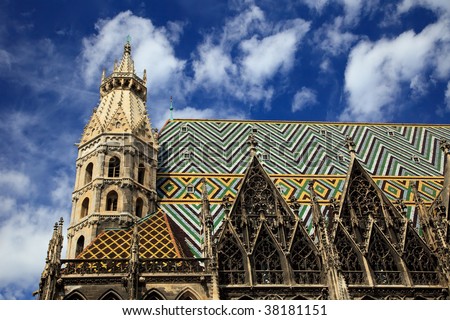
[219,233,245,284]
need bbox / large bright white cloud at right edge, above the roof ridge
[340,21,450,121]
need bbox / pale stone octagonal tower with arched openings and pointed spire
[67,42,158,259]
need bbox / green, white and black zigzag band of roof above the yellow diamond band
[159,120,450,176]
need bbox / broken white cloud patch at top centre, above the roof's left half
[192,4,310,109]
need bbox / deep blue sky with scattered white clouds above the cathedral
[0,0,450,299]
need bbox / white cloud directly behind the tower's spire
[81,11,185,90]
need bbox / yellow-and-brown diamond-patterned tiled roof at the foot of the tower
[77,211,181,259]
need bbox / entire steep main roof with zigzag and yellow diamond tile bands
[157,120,450,256]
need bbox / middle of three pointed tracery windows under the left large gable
[253,231,283,284]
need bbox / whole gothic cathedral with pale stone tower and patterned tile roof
[36,42,450,300]
